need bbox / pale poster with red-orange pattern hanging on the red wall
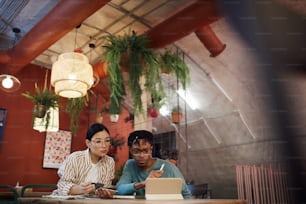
[43,130,72,168]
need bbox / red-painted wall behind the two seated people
[0,64,133,186]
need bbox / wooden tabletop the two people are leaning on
[18,197,247,204]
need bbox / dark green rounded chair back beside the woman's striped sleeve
[20,184,57,197]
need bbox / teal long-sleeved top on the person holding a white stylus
[116,158,191,199]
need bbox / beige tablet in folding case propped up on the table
[145,178,183,200]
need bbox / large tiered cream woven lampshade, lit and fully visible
[51,52,93,98]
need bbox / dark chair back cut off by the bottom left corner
[0,185,19,204]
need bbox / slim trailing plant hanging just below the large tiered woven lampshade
[66,95,87,135]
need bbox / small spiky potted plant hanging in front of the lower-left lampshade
[22,84,59,129]
